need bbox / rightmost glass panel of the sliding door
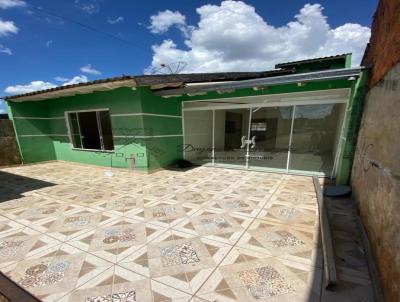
[289,104,345,175]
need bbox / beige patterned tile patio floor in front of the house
[0,162,322,302]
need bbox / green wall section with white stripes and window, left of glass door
[8,88,182,171]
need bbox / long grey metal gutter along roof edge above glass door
[154,67,363,97]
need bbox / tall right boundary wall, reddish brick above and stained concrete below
[351,0,400,302]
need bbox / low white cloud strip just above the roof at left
[4,75,88,94]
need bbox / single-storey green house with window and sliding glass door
[4,54,367,183]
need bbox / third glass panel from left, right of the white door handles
[249,106,293,170]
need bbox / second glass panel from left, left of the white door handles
[214,108,250,166]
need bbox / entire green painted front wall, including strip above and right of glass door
[8,63,365,183]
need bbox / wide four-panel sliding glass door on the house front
[185,103,346,175]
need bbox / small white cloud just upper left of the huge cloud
[148,9,189,36]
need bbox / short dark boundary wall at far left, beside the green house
[0,119,21,166]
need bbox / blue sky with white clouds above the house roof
[0,0,377,113]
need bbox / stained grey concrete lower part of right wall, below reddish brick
[351,64,400,301]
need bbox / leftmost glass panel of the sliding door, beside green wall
[183,110,213,165]
